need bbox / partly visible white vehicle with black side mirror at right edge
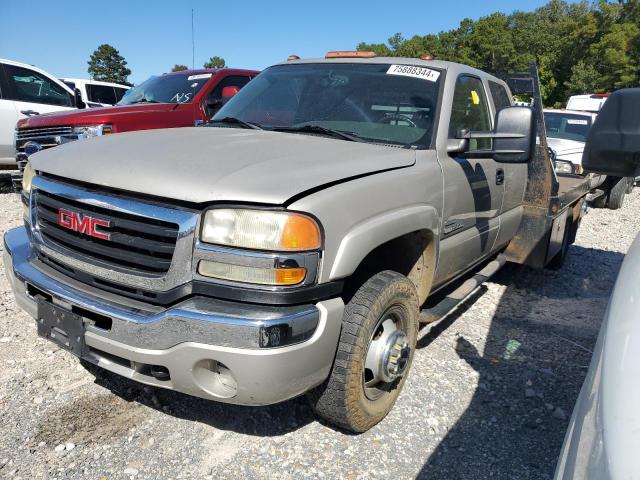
[555,88,640,480]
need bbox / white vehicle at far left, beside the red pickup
[0,58,76,166]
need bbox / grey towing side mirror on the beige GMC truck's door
[447,107,535,163]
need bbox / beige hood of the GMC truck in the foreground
[30,127,415,205]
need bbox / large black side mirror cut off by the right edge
[582,88,640,177]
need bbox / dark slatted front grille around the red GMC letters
[34,190,178,274]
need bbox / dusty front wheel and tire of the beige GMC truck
[309,271,418,433]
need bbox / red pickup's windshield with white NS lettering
[117,73,212,105]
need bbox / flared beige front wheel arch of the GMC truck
[329,205,440,296]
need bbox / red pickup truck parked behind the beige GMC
[15,68,259,171]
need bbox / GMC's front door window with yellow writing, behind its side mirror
[449,75,491,150]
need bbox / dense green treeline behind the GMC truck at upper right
[357,0,640,105]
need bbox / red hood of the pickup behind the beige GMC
[16,103,177,128]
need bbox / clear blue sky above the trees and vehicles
[0,0,568,83]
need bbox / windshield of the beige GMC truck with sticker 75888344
[213,63,440,147]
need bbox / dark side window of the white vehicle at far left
[4,65,73,107]
